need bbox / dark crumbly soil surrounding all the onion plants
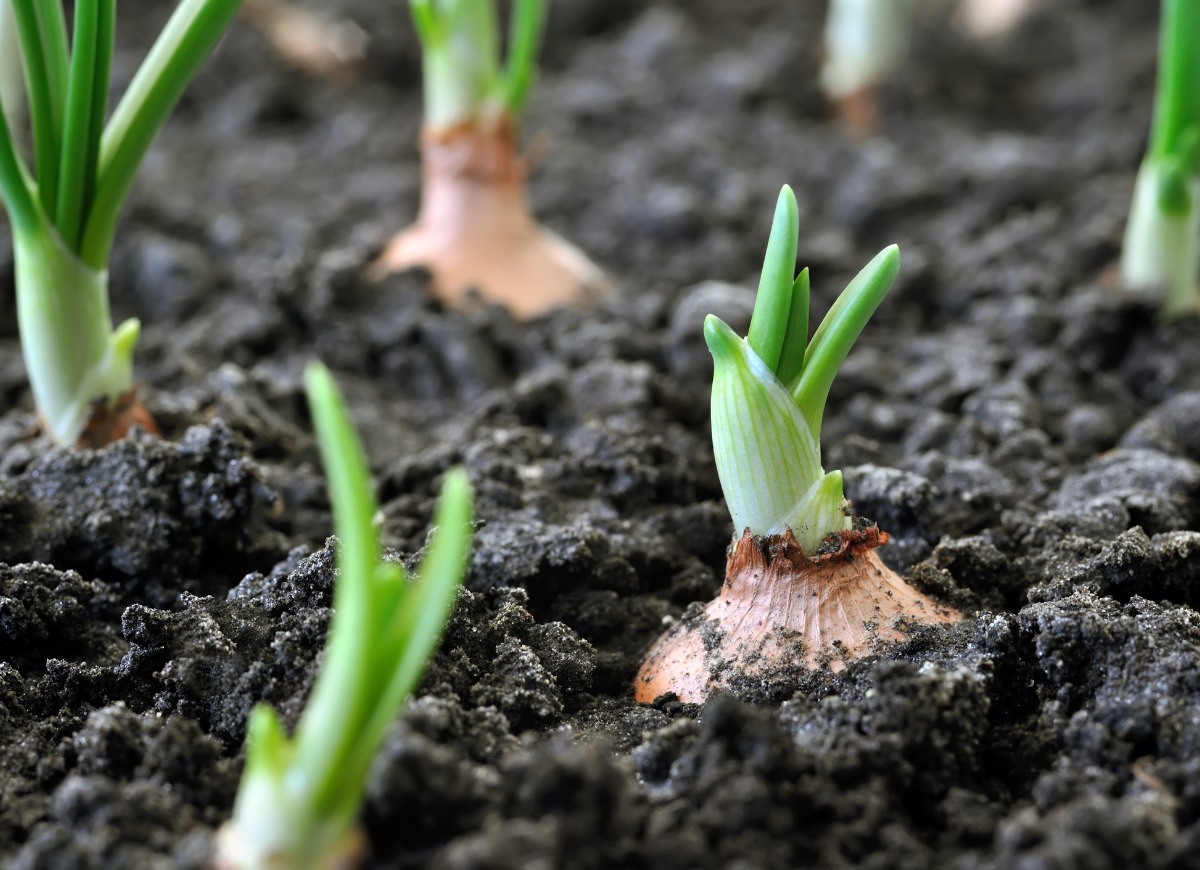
[0,0,1200,869]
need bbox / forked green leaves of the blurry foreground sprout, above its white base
[296,364,470,818]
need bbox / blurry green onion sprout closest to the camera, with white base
[217,364,472,870]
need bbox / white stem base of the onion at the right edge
[1121,160,1200,317]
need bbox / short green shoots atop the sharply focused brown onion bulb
[704,185,900,554]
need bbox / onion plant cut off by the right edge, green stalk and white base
[1121,0,1200,317]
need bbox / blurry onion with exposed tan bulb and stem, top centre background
[374,0,607,317]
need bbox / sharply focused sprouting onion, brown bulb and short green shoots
[635,186,960,703]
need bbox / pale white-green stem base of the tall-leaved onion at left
[13,228,140,445]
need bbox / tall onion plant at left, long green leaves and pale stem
[0,0,241,444]
